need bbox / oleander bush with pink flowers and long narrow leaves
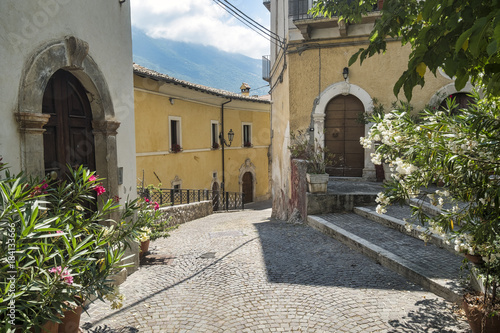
[0,163,146,332]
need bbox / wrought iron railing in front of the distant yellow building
[138,188,245,211]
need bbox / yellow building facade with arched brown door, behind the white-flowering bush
[264,0,472,220]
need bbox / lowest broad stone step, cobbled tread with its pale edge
[307,212,468,302]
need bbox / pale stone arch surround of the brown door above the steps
[312,81,375,180]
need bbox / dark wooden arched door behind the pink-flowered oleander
[42,70,95,177]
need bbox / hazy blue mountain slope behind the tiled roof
[132,27,269,95]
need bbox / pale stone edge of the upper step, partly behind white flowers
[353,207,463,257]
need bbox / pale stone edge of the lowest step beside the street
[307,215,461,303]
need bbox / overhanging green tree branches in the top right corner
[311,0,500,100]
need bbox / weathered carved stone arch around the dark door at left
[15,36,120,195]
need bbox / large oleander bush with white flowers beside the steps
[361,92,500,332]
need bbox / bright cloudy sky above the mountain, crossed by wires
[130,0,270,59]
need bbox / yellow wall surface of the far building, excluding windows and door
[134,75,271,201]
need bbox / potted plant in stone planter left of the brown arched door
[288,130,334,193]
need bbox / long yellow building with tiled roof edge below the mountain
[134,65,271,202]
